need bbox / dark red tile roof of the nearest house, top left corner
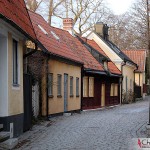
[0,0,36,39]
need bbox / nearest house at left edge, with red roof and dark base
[0,0,35,137]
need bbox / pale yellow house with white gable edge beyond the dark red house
[87,23,137,102]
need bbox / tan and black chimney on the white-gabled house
[95,22,109,40]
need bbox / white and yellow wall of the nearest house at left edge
[0,19,24,117]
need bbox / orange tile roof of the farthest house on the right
[123,49,146,72]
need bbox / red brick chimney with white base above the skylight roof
[63,18,74,35]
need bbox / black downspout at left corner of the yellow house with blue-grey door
[46,57,49,120]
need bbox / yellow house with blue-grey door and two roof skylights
[29,11,83,117]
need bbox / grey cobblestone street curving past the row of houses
[16,97,150,150]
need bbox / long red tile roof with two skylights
[29,12,104,71]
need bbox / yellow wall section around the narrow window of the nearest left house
[8,33,23,115]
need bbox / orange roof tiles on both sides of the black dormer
[81,38,121,74]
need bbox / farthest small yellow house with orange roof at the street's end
[123,49,146,97]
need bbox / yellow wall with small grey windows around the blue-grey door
[42,59,81,115]
